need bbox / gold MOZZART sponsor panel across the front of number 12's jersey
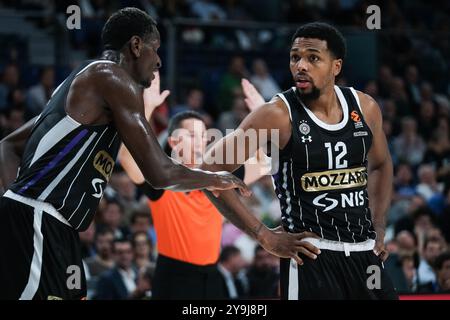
[301,167,367,192]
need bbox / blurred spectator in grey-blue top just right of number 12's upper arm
[394,117,426,166]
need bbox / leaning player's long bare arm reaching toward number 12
[95,65,249,195]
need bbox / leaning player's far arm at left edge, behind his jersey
[0,117,37,195]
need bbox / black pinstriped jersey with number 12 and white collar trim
[273,86,376,242]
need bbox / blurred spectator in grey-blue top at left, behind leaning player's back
[27,67,55,118]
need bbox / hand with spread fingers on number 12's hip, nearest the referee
[261,227,320,265]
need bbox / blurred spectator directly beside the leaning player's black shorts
[85,228,114,278]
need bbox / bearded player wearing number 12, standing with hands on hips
[202,23,397,300]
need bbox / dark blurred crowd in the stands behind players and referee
[0,0,450,299]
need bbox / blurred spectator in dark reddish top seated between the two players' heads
[217,56,248,112]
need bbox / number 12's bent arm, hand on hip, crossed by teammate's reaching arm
[201,99,320,264]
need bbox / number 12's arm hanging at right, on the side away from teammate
[358,92,393,261]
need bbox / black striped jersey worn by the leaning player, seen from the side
[10,60,120,231]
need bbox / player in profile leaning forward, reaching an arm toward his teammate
[0,8,260,299]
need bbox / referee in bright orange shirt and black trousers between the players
[120,111,225,299]
